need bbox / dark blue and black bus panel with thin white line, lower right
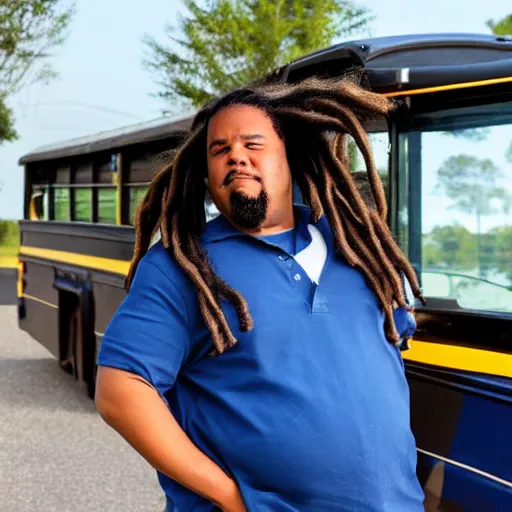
[409,377,512,512]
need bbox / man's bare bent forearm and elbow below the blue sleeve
[95,366,246,512]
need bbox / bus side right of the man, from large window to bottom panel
[394,95,512,511]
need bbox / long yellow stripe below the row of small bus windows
[20,245,131,275]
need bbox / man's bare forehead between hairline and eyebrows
[208,105,277,140]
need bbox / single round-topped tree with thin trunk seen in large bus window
[437,155,512,276]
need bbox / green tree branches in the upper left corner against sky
[0,0,74,144]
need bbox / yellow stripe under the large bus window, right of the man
[402,340,512,377]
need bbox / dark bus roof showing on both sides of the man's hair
[20,34,512,164]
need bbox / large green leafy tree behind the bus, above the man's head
[143,0,371,110]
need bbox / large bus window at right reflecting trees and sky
[400,104,512,312]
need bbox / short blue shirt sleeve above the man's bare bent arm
[98,259,190,394]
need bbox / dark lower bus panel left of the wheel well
[19,261,59,358]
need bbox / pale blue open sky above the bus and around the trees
[0,0,512,225]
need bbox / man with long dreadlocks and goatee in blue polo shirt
[96,79,423,512]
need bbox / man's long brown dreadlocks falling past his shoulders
[126,78,423,354]
